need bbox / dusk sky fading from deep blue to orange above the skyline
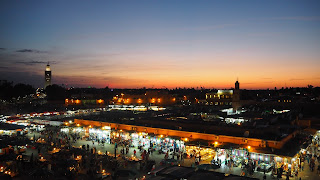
[0,0,320,89]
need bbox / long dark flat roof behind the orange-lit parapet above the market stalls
[72,112,296,141]
